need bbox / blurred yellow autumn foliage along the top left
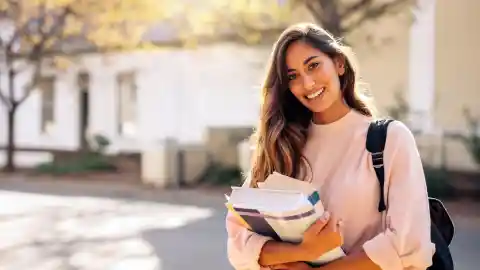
[0,0,289,55]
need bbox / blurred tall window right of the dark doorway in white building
[117,72,137,137]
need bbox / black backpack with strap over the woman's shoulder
[366,119,455,270]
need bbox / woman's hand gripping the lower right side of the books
[299,211,342,261]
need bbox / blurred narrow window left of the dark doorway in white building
[38,76,55,133]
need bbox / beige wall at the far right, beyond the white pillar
[435,0,480,170]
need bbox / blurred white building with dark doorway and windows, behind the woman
[0,43,270,166]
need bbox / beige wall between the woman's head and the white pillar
[350,16,410,118]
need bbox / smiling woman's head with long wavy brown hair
[252,24,374,185]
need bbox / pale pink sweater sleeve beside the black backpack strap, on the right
[363,122,435,270]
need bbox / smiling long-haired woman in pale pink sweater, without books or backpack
[226,24,434,270]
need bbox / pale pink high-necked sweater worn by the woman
[226,110,435,270]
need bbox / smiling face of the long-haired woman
[286,41,345,113]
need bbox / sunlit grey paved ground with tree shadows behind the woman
[0,179,480,270]
